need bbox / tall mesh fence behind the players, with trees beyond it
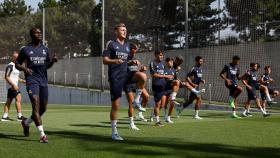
[0,0,280,105]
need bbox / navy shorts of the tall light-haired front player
[109,76,127,101]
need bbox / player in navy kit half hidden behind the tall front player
[125,44,149,131]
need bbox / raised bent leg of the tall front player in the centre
[132,72,147,111]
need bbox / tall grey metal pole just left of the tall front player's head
[101,0,105,91]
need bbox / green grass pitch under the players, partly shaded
[0,105,280,158]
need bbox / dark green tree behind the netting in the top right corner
[225,0,280,42]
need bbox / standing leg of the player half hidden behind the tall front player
[126,91,139,131]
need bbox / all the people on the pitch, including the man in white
[1,23,279,143]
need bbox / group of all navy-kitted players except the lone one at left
[103,23,279,140]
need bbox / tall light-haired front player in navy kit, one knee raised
[102,23,145,140]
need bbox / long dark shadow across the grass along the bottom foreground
[44,131,280,158]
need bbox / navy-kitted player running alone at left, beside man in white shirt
[15,28,57,143]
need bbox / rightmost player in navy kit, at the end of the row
[260,66,279,110]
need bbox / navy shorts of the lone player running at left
[26,84,49,101]
